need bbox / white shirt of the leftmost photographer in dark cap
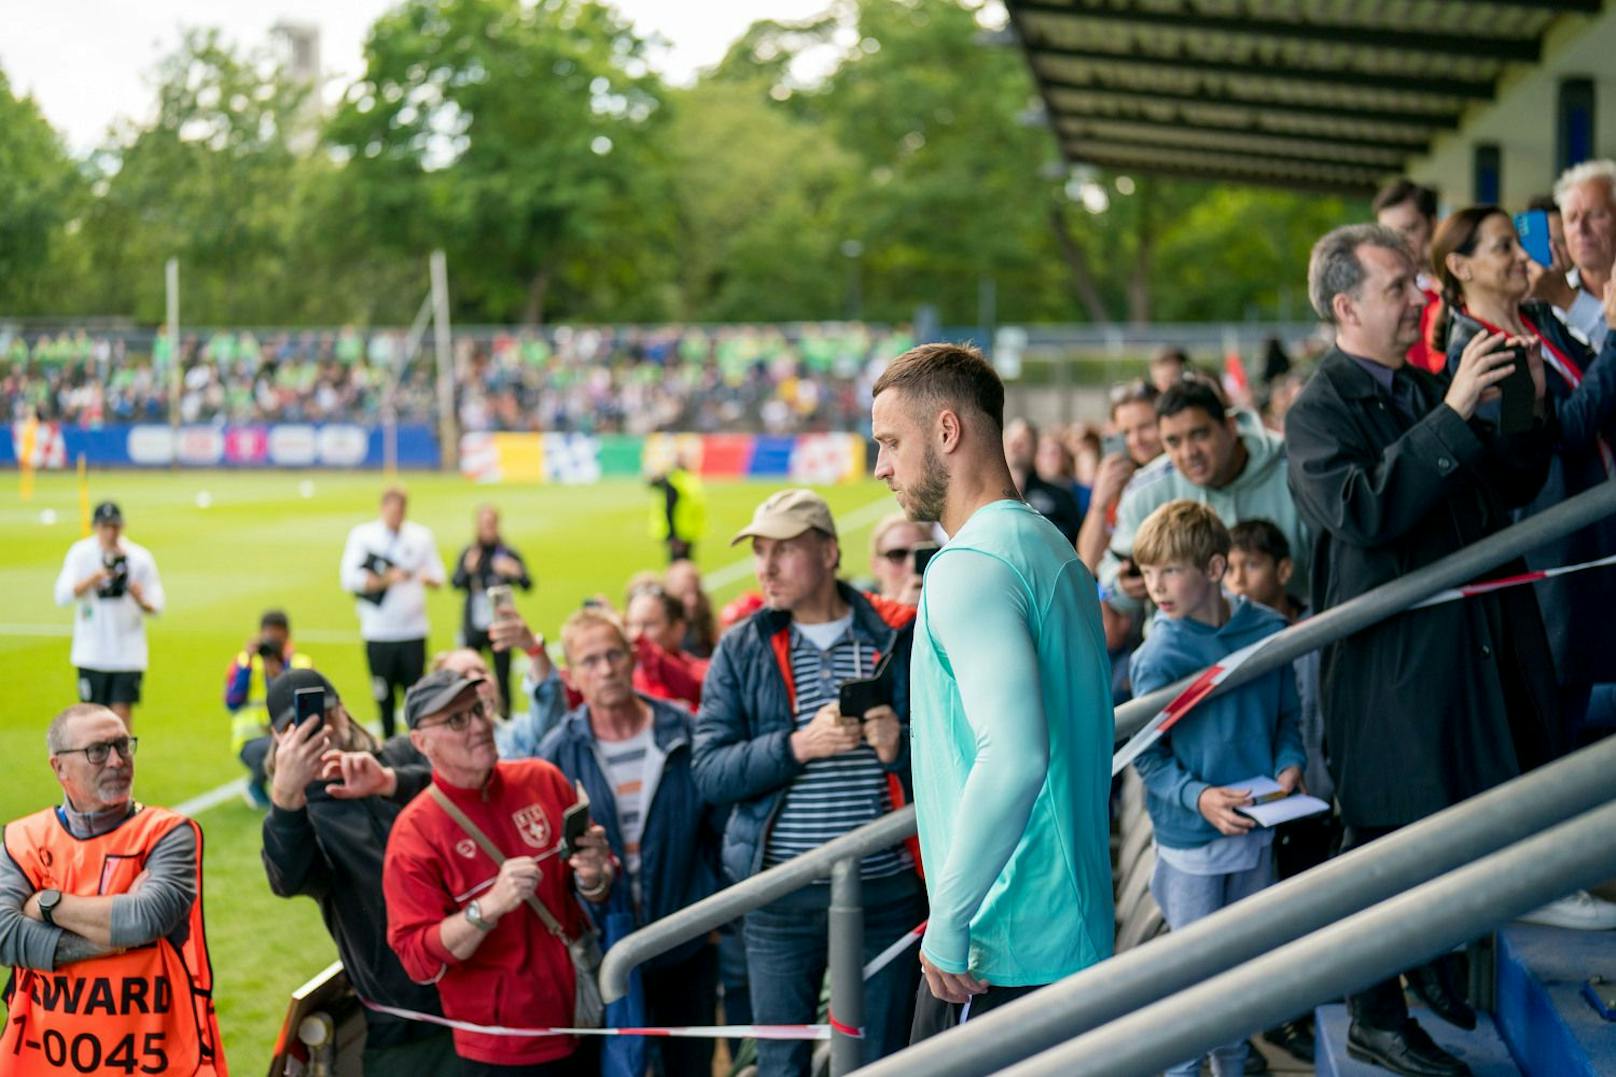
[57,535,163,673]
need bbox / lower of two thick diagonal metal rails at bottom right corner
[995,804,1616,1077]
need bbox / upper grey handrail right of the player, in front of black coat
[1117,482,1616,741]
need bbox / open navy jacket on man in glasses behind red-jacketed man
[538,695,722,969]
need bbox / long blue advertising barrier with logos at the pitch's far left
[0,422,441,471]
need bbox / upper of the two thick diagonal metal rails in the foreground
[863,739,1616,1077]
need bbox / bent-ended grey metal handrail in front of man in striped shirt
[601,795,915,1003]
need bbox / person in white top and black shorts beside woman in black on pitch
[343,487,446,739]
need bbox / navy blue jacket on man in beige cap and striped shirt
[695,582,915,881]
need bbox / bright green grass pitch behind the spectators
[0,472,895,1074]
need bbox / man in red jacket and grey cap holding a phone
[381,669,616,1077]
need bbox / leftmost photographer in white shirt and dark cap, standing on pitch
[57,501,163,731]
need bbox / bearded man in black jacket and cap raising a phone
[263,669,459,1077]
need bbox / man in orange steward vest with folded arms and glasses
[0,703,228,1077]
